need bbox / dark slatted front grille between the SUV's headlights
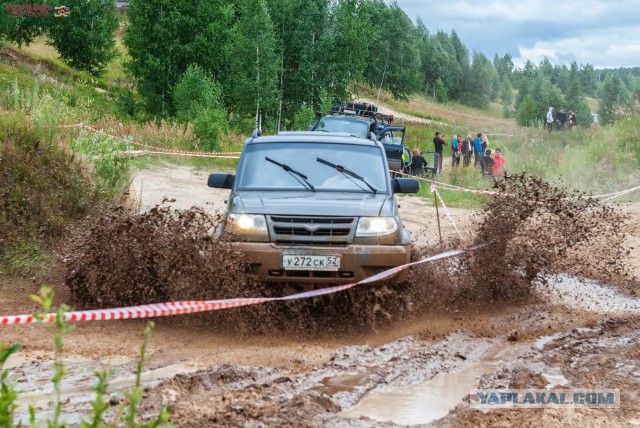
[269,215,356,246]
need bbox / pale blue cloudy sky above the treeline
[397,0,640,68]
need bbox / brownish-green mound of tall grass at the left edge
[0,112,93,251]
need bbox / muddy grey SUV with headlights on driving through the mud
[208,132,419,284]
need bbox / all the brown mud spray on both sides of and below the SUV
[66,174,629,337]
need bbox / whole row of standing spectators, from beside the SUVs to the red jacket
[409,132,505,177]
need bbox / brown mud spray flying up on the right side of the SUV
[412,174,633,310]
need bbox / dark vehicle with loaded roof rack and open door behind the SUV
[309,102,406,172]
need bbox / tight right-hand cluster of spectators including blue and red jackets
[450,132,505,176]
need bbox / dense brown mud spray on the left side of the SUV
[64,206,246,308]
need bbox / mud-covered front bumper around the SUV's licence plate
[231,242,411,284]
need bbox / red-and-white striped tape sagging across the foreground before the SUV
[0,244,486,325]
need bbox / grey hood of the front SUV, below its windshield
[229,191,397,217]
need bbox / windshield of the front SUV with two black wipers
[237,142,388,193]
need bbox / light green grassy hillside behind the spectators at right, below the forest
[359,87,640,206]
